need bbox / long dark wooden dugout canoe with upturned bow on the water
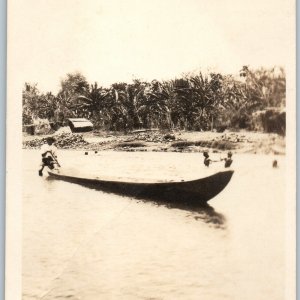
[48,170,234,203]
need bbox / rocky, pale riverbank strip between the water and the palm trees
[23,128,285,155]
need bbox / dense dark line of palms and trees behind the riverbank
[22,66,286,131]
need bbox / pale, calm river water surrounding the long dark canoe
[22,150,287,300]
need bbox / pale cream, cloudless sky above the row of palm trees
[8,0,294,93]
